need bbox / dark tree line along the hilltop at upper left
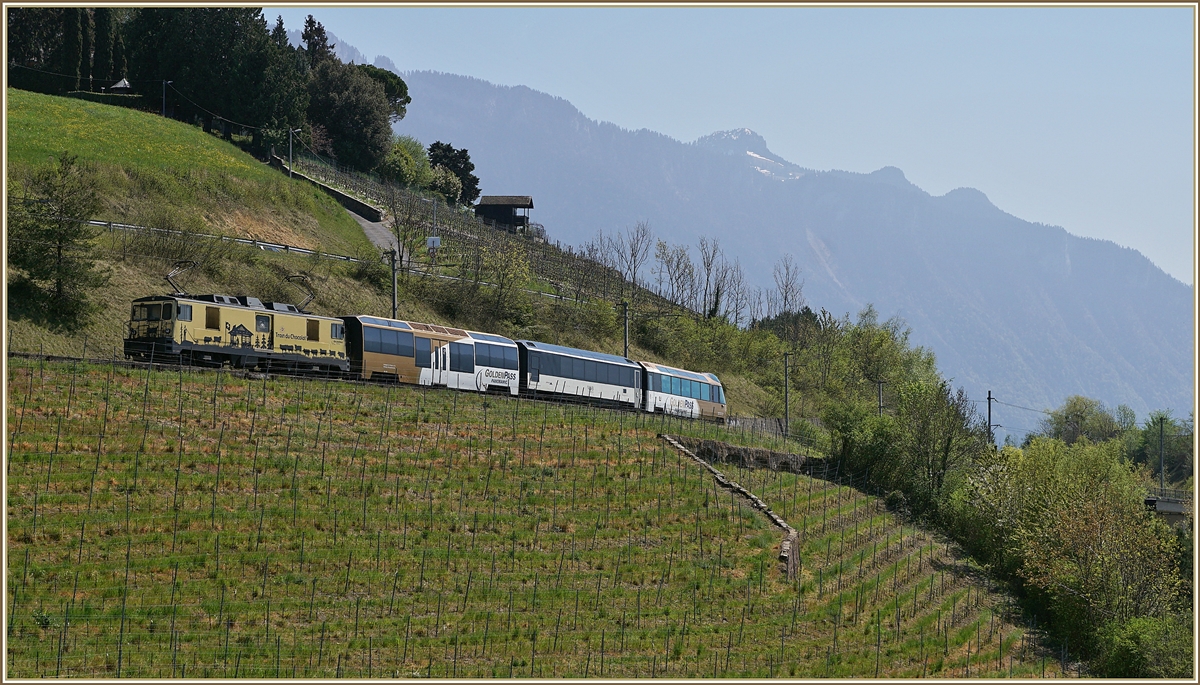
[7,7,479,204]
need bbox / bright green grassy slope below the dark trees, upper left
[7,88,370,254]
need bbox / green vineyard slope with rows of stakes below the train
[6,360,1057,678]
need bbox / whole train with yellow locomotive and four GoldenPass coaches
[125,293,726,422]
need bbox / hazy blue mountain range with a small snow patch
[386,72,1194,424]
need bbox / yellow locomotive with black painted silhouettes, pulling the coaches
[125,294,350,373]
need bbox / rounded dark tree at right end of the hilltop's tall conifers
[308,59,392,172]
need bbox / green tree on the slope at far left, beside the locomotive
[8,152,108,324]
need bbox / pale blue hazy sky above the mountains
[276,7,1195,284]
